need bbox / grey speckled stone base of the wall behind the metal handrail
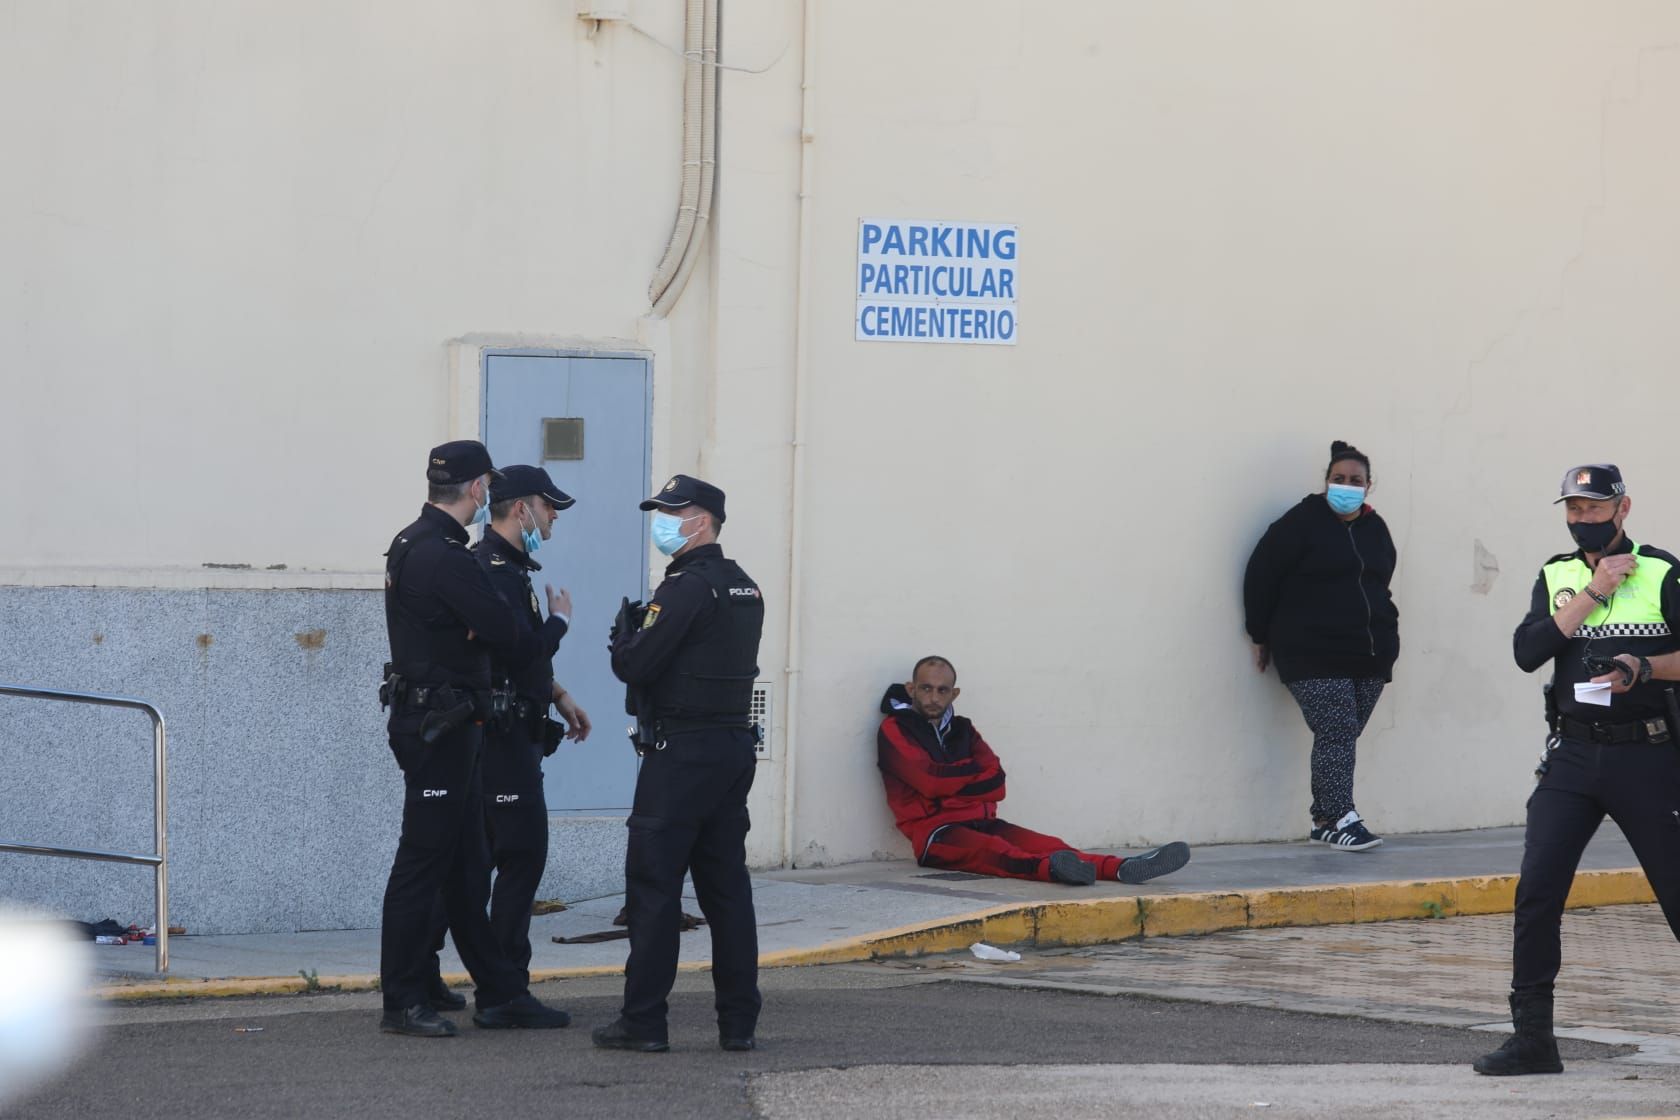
[0,588,658,934]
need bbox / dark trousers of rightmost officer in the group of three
[623,727,763,1041]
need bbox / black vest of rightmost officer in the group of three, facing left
[650,556,764,727]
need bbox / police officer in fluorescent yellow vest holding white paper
[1475,463,1680,1075]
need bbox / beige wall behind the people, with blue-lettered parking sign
[0,0,1680,863]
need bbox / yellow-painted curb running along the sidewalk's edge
[94,868,1655,1001]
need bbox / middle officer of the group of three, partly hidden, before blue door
[472,467,590,977]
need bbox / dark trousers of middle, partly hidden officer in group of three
[432,729,548,984]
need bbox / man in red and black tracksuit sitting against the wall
[875,657,1189,887]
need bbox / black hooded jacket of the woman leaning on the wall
[1243,494,1399,682]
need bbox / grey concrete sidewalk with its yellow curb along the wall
[97,821,1651,999]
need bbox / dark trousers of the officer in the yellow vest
[1510,739,1680,992]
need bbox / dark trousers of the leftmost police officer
[380,712,526,1011]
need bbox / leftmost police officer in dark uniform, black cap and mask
[380,440,570,1038]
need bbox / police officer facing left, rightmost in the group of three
[591,475,764,1051]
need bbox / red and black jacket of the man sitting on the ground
[875,685,1003,861]
